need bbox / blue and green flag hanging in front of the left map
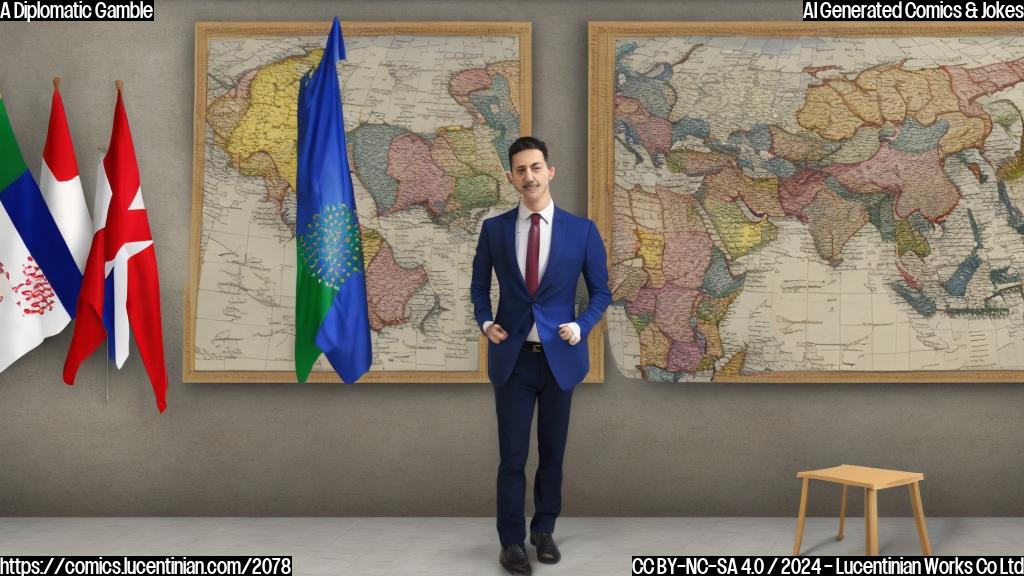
[295,18,373,384]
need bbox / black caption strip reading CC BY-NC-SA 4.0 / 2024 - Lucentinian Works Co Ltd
[633,556,1024,576]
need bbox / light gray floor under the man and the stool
[0,518,1024,576]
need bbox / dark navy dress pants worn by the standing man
[494,342,572,546]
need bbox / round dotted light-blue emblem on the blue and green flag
[298,203,362,289]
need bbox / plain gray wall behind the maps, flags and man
[0,0,1024,516]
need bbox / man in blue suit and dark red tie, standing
[470,136,611,574]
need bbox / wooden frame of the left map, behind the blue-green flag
[182,22,544,383]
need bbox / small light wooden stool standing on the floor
[793,464,932,556]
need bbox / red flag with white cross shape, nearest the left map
[63,87,167,412]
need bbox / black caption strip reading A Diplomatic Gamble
[0,0,157,22]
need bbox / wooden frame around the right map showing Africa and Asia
[588,22,1024,383]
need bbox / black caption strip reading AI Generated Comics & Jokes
[803,0,1024,22]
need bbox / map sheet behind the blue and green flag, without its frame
[195,36,520,372]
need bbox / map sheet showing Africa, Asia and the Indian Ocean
[609,37,1024,381]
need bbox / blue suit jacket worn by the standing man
[470,206,611,390]
